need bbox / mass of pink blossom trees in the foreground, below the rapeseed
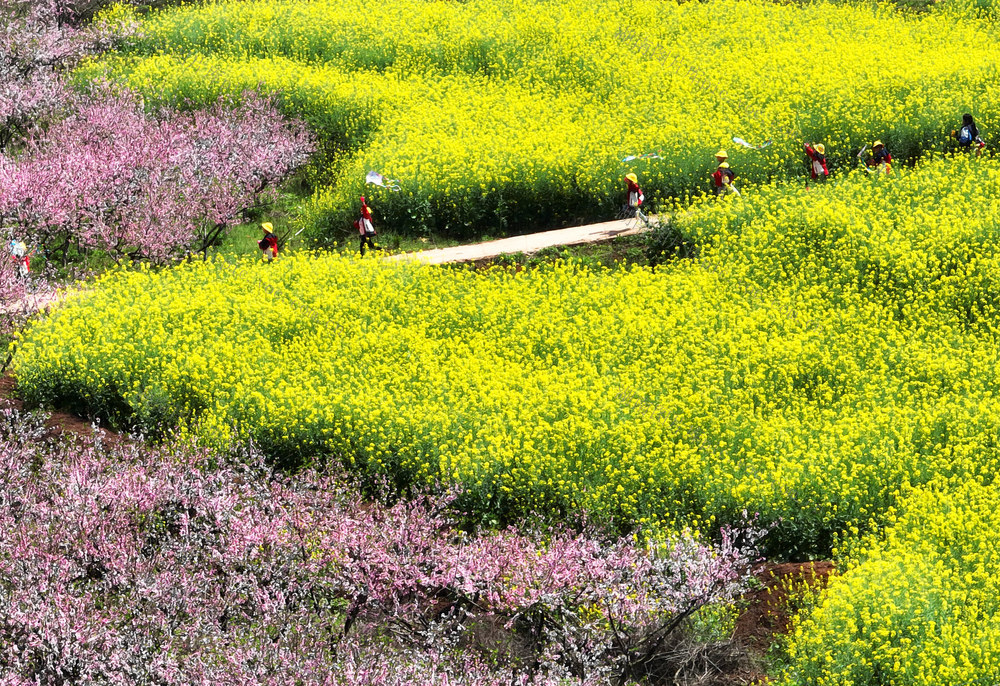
[0,411,759,686]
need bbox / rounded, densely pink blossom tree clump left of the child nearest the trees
[0,91,312,263]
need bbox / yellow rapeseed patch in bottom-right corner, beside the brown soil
[779,483,1000,686]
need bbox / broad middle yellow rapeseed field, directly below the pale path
[15,158,1000,553]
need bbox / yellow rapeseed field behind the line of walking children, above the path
[83,0,1000,237]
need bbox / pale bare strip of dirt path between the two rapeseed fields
[386,217,656,264]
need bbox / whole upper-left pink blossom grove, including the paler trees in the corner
[0,0,312,284]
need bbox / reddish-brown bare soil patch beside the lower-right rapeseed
[734,561,836,655]
